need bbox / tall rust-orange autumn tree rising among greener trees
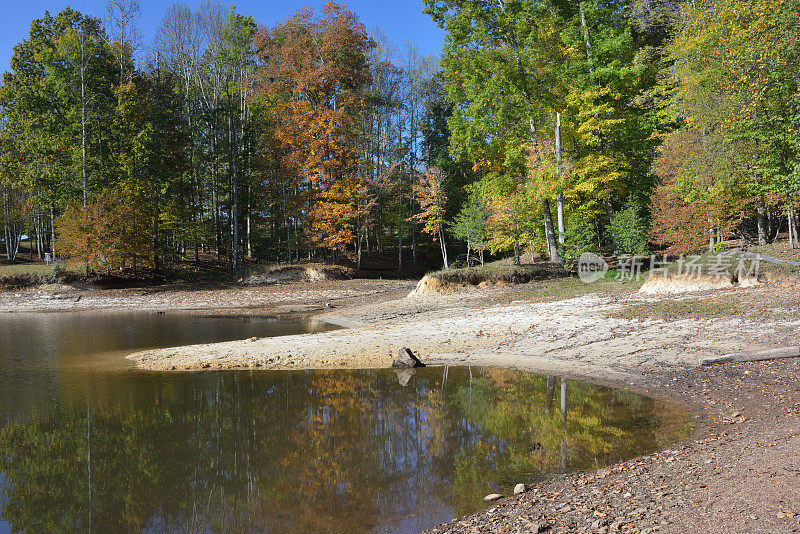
[255,2,374,255]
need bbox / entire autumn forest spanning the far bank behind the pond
[0,0,800,272]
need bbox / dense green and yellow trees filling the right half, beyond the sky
[425,0,800,262]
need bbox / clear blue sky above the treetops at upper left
[0,0,444,72]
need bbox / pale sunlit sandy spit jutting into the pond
[111,282,800,383]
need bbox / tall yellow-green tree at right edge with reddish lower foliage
[654,0,800,248]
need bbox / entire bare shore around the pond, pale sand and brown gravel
[0,281,800,533]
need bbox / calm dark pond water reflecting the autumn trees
[0,313,689,532]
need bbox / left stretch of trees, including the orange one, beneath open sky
[0,0,441,270]
